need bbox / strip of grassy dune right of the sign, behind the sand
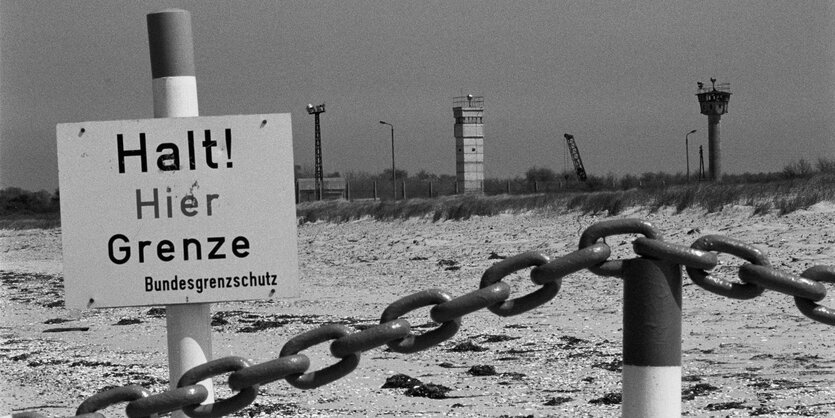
[296,174,835,222]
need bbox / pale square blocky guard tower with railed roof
[452,94,484,193]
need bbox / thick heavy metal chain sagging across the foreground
[12,219,835,418]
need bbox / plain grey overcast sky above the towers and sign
[0,0,835,191]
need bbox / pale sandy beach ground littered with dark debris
[0,204,835,417]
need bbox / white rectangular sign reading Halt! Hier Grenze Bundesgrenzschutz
[57,114,298,308]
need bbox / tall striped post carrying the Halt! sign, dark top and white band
[147,9,214,418]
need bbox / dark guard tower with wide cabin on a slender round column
[696,78,731,181]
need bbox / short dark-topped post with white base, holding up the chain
[621,257,681,418]
